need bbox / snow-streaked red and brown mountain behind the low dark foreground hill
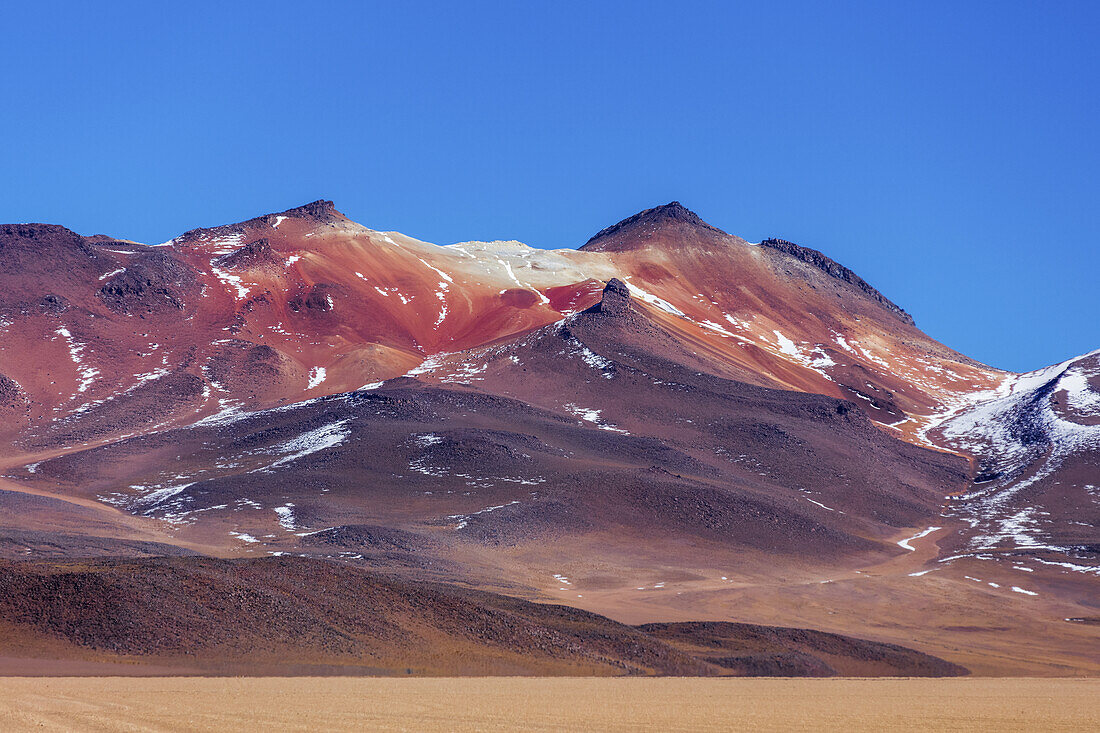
[0,201,1100,675]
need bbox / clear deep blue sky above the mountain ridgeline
[0,1,1100,370]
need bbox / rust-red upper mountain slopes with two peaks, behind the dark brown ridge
[0,201,1003,449]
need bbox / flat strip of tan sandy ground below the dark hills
[0,677,1100,731]
